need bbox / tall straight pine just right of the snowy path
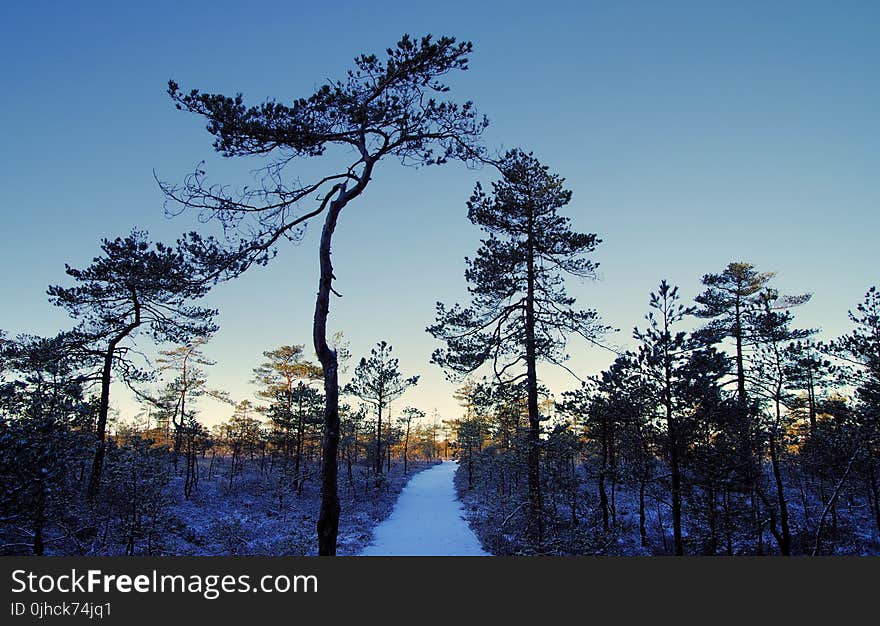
[427,150,605,544]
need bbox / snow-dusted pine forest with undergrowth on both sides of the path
[0,36,880,556]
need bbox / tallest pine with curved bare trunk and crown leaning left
[162,35,488,555]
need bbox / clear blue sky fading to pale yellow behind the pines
[0,1,880,424]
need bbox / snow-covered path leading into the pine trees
[361,462,490,556]
